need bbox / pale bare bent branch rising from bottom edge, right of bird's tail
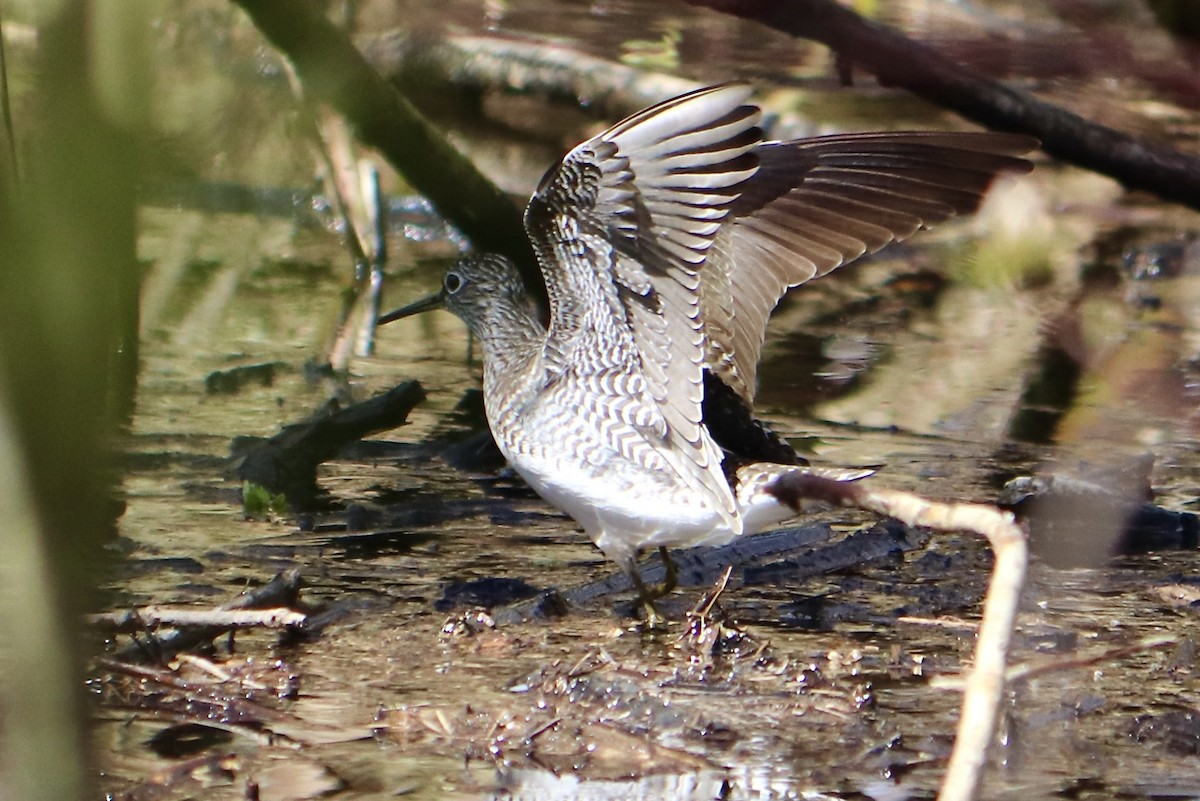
[768,472,1028,801]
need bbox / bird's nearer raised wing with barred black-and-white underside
[526,84,761,520]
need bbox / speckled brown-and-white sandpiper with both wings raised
[378,82,1037,622]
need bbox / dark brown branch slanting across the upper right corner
[688,0,1200,209]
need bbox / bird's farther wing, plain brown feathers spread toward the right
[701,131,1038,404]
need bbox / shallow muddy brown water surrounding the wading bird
[95,2,1200,799]
